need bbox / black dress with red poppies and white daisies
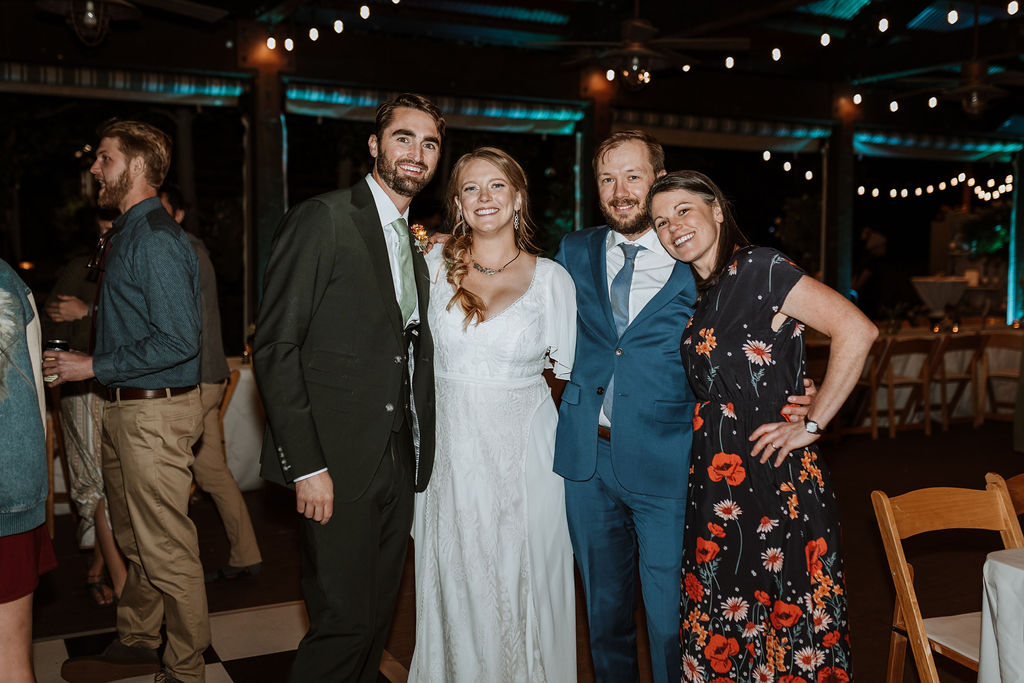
[681,247,852,683]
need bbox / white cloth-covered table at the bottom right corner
[978,548,1024,683]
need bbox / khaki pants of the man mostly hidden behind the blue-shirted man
[193,382,263,567]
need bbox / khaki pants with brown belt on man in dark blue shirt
[102,390,210,683]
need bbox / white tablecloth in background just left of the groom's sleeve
[224,358,266,490]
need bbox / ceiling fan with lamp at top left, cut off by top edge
[36,0,227,46]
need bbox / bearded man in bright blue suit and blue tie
[554,131,697,683]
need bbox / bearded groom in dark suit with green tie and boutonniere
[253,94,444,683]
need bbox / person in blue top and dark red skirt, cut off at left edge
[0,255,57,683]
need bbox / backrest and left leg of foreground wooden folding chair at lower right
[871,477,1024,683]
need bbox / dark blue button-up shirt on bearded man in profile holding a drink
[92,197,203,389]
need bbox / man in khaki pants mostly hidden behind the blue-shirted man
[160,184,263,584]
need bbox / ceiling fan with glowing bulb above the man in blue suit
[534,0,751,89]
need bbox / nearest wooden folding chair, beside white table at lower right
[871,478,1024,683]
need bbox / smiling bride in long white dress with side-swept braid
[409,147,577,683]
